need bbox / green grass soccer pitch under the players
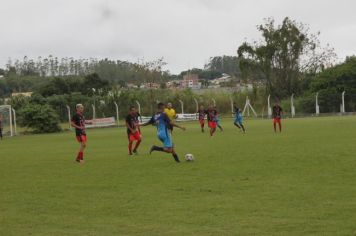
[0,117,356,236]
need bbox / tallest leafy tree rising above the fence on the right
[237,17,335,97]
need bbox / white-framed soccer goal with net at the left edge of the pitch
[0,105,17,136]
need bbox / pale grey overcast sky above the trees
[0,0,356,73]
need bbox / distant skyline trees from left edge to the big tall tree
[4,55,241,82]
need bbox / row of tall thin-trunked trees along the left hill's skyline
[5,55,168,81]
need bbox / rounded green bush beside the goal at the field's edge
[19,104,61,133]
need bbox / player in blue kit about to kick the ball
[142,103,185,162]
